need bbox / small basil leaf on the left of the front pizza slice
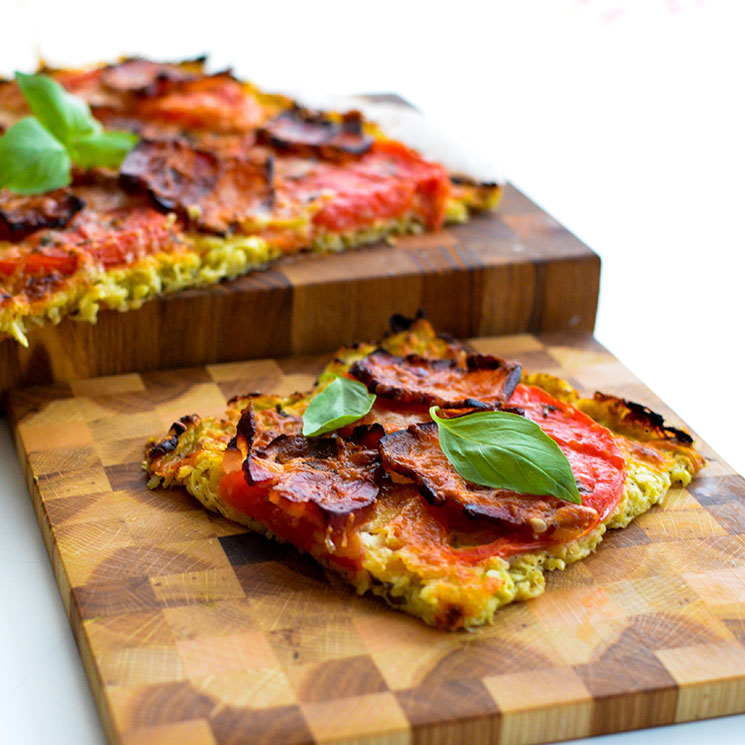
[303,377,375,437]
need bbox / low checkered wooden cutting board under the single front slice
[9,334,745,745]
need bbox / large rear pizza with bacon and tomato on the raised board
[0,59,501,344]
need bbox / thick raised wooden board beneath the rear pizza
[0,186,600,407]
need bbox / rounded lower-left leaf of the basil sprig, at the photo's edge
[0,116,70,194]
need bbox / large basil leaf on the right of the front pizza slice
[429,406,582,504]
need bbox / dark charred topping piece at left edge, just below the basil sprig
[0,189,85,241]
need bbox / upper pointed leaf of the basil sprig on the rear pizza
[16,72,102,145]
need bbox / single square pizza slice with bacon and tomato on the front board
[144,319,704,629]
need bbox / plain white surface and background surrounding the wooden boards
[0,0,745,745]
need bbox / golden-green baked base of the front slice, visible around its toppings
[144,320,704,629]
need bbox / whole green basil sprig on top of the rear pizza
[0,72,137,194]
